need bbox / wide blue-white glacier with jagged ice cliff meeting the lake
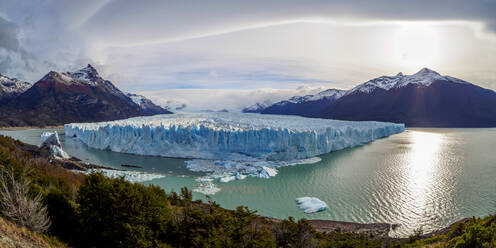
[65,113,405,161]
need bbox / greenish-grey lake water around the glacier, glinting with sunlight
[0,128,496,236]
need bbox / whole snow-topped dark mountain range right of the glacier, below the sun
[244,68,496,127]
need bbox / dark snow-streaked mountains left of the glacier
[0,65,171,126]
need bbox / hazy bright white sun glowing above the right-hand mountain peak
[394,23,441,70]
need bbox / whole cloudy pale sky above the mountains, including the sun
[0,0,496,110]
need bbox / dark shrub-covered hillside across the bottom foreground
[0,136,496,247]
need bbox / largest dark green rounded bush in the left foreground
[76,173,171,247]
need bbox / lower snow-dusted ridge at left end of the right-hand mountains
[260,89,346,116]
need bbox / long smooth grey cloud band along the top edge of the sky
[79,0,496,45]
